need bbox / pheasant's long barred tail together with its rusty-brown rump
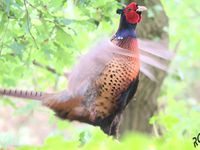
[0,88,90,123]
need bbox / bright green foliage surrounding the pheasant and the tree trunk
[0,0,200,150]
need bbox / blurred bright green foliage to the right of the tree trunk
[158,0,200,136]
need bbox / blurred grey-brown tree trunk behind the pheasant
[120,0,168,133]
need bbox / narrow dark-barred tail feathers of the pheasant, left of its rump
[0,88,50,100]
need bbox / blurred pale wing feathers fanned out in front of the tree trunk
[139,40,174,81]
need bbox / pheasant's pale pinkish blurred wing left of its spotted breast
[68,38,138,95]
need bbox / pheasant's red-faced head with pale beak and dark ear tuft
[117,2,147,24]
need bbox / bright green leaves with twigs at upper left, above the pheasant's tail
[0,0,117,90]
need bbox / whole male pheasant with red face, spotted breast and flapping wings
[0,2,171,135]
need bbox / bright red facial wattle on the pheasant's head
[124,2,141,24]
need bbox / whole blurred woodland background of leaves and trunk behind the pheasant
[0,0,200,150]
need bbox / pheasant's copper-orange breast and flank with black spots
[92,38,140,119]
